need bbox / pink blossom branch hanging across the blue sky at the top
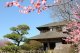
[5,0,47,14]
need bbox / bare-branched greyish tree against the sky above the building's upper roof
[52,0,80,20]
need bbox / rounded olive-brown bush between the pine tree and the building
[21,40,42,50]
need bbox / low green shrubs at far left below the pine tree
[0,42,20,53]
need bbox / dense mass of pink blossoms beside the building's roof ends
[65,21,80,44]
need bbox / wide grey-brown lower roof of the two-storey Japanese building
[30,31,68,39]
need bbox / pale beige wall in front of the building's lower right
[53,44,74,53]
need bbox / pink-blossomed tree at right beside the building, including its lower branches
[64,21,80,53]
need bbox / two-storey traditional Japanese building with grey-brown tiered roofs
[31,21,69,50]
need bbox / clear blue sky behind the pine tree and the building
[0,0,57,39]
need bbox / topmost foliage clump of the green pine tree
[10,25,30,35]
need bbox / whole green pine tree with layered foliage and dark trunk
[4,25,30,46]
